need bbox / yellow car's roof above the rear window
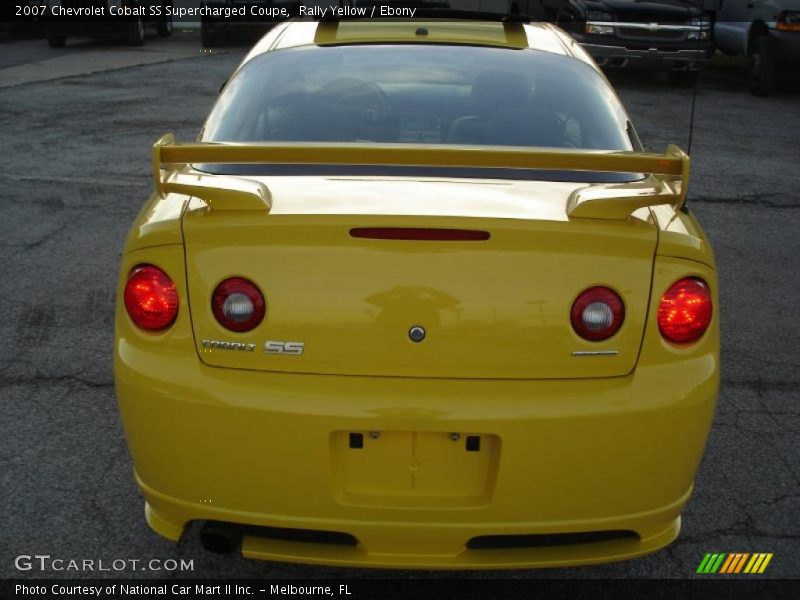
[234,19,594,65]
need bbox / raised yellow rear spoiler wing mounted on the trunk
[152,134,689,219]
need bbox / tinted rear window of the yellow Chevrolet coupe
[202,44,632,150]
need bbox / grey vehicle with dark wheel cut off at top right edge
[714,0,800,96]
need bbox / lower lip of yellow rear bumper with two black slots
[141,476,691,569]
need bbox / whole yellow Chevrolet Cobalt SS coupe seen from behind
[115,19,719,569]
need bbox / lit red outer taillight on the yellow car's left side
[125,265,178,331]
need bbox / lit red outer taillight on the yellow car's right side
[658,278,713,344]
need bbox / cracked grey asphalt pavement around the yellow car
[0,34,800,578]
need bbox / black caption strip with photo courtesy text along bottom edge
[0,570,800,600]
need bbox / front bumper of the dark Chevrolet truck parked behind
[582,44,709,71]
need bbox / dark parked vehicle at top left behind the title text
[45,0,173,48]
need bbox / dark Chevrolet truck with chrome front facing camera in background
[520,0,713,85]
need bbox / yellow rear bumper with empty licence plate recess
[116,339,718,568]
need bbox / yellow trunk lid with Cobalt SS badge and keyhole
[183,177,657,379]
